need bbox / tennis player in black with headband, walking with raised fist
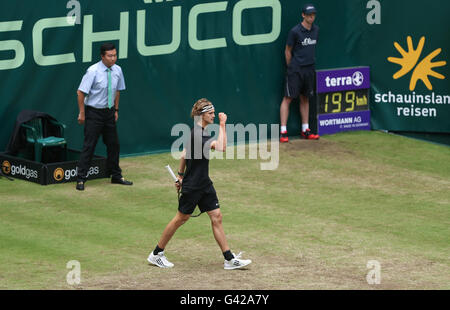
[147,98,252,270]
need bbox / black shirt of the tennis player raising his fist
[182,124,212,193]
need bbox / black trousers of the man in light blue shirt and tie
[78,106,122,181]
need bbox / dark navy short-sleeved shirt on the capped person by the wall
[286,23,319,71]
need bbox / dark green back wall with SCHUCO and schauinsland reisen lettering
[0,0,450,155]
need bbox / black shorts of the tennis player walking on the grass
[178,184,220,214]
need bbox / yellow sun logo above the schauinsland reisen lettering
[387,36,447,91]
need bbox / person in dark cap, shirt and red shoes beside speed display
[280,4,319,142]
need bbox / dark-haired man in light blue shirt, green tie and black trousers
[76,43,133,190]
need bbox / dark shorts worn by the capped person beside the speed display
[284,65,316,98]
